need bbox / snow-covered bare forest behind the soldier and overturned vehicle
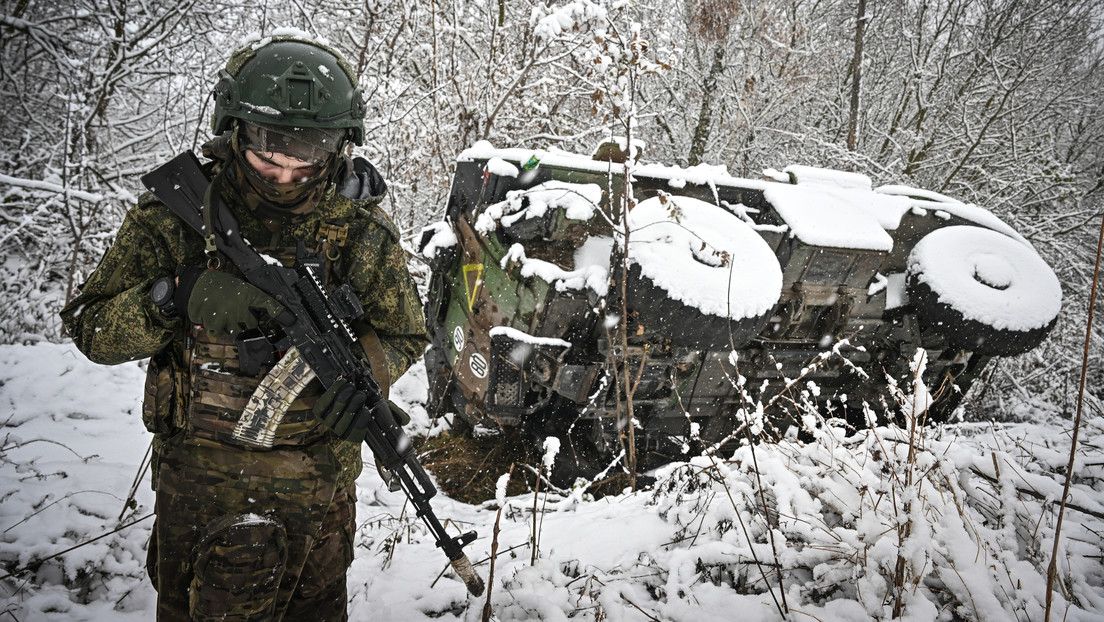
[0,0,1104,414]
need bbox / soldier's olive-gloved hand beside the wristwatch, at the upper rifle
[177,267,284,337]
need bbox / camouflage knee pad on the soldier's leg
[189,514,287,622]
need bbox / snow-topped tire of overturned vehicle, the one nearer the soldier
[626,197,782,349]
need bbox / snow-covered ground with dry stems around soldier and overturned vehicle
[0,342,1104,622]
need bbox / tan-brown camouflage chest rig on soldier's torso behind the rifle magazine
[184,221,349,450]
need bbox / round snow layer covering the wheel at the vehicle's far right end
[909,226,1062,330]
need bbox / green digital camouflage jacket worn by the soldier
[62,153,428,484]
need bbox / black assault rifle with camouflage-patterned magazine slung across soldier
[141,151,484,595]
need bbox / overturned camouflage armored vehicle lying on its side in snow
[421,143,1061,476]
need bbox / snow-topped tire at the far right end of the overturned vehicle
[906,225,1062,356]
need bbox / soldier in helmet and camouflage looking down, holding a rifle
[62,36,428,621]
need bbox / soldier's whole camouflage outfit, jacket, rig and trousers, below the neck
[62,148,427,620]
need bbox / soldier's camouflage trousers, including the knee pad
[147,441,355,622]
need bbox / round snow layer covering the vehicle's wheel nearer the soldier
[628,196,782,319]
